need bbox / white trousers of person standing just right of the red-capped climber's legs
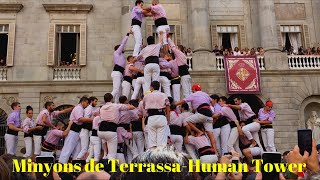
[213,124,231,156]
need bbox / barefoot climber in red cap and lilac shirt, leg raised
[175,84,217,151]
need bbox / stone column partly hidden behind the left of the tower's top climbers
[119,0,134,55]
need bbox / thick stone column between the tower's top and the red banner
[189,0,216,71]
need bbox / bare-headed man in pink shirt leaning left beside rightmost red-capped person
[225,96,262,148]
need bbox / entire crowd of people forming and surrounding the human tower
[0,0,319,179]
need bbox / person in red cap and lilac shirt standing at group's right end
[254,101,276,152]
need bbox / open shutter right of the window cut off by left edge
[7,23,16,66]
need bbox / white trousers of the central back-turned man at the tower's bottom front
[148,115,168,147]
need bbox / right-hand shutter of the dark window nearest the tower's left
[79,24,87,66]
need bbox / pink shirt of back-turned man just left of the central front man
[100,102,129,124]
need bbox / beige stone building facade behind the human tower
[0,0,320,155]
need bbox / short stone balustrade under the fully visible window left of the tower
[53,67,81,81]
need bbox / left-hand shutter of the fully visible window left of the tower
[47,23,56,66]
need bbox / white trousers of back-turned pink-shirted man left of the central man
[98,131,118,159]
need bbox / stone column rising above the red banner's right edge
[258,0,288,70]
